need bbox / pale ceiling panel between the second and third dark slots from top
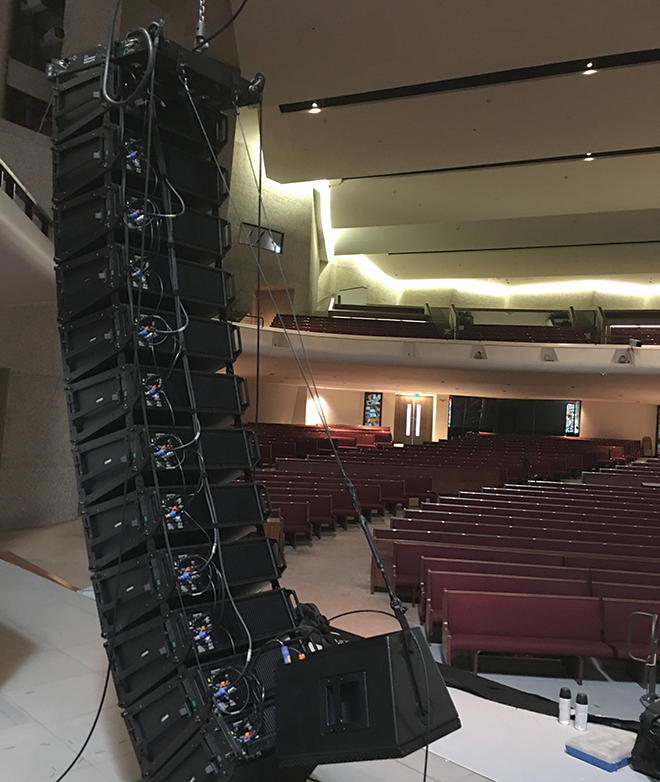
[330,153,660,228]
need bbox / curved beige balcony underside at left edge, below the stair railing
[0,191,55,305]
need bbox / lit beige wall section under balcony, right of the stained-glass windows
[580,402,660,444]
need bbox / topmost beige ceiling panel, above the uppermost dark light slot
[232,0,660,105]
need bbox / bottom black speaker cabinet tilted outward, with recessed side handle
[276,627,460,766]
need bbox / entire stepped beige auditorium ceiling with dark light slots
[232,0,660,281]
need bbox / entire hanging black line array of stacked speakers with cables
[48,23,457,782]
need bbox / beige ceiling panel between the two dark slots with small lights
[264,63,660,182]
